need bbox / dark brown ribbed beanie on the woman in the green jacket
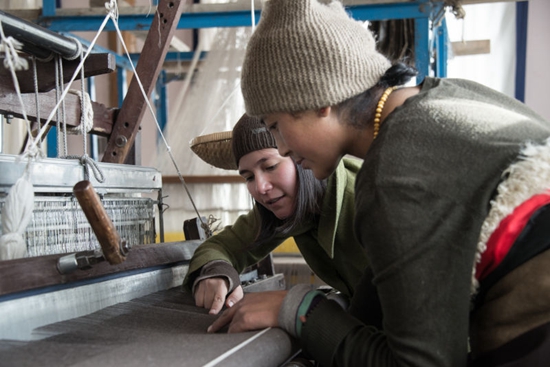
[231,114,277,167]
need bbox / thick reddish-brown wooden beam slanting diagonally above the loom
[103,0,188,163]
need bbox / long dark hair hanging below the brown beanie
[251,163,327,247]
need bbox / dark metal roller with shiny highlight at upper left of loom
[0,10,82,60]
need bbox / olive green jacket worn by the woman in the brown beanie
[183,158,368,297]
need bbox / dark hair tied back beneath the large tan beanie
[336,62,418,129]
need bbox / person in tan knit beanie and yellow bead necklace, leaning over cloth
[210,0,550,367]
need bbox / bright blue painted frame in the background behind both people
[36,0,447,147]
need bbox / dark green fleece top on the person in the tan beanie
[294,78,550,367]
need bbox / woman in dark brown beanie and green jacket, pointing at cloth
[183,115,367,320]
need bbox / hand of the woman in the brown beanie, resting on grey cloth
[195,278,243,315]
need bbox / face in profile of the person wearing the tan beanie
[264,109,345,180]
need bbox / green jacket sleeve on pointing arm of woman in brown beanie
[183,210,285,291]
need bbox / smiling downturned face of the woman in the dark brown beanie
[239,148,298,219]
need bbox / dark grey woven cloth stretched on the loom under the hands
[0,287,297,367]
